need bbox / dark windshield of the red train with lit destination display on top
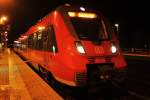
[68,12,110,42]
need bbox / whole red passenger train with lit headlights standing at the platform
[13,5,126,86]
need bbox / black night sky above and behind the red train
[0,0,150,48]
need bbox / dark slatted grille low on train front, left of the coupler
[75,72,86,86]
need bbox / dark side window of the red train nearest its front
[43,25,58,53]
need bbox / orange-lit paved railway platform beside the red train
[0,49,63,100]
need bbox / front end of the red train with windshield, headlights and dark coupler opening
[57,7,126,86]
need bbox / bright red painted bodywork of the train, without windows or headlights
[16,5,126,84]
